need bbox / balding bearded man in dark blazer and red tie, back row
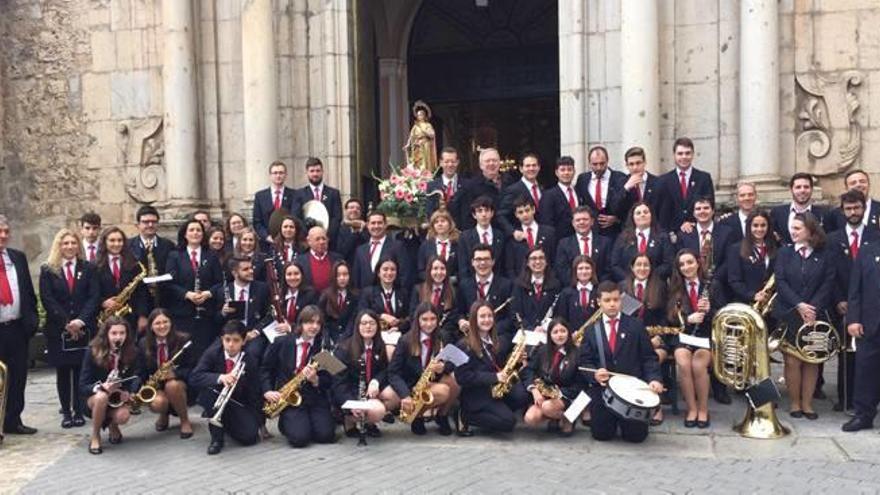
[574,146,627,242]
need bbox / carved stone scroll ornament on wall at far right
[795,70,862,176]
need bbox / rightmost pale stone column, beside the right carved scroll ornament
[739,0,780,183]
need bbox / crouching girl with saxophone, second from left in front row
[137,308,198,439]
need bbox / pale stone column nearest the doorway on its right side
[620,0,660,172]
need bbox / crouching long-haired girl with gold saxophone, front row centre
[388,302,459,436]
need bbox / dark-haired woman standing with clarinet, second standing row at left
[164,220,223,359]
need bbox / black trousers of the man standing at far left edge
[0,319,30,430]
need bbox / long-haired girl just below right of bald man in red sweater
[318,261,358,347]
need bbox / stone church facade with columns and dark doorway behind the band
[0,0,880,258]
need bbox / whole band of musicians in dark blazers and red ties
[0,138,880,454]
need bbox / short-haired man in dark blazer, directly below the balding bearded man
[553,205,612,287]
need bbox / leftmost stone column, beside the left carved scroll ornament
[162,0,202,201]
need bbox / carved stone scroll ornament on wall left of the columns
[118,118,165,204]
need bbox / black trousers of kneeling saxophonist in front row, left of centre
[278,397,336,448]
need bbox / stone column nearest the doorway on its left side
[241,0,276,195]
